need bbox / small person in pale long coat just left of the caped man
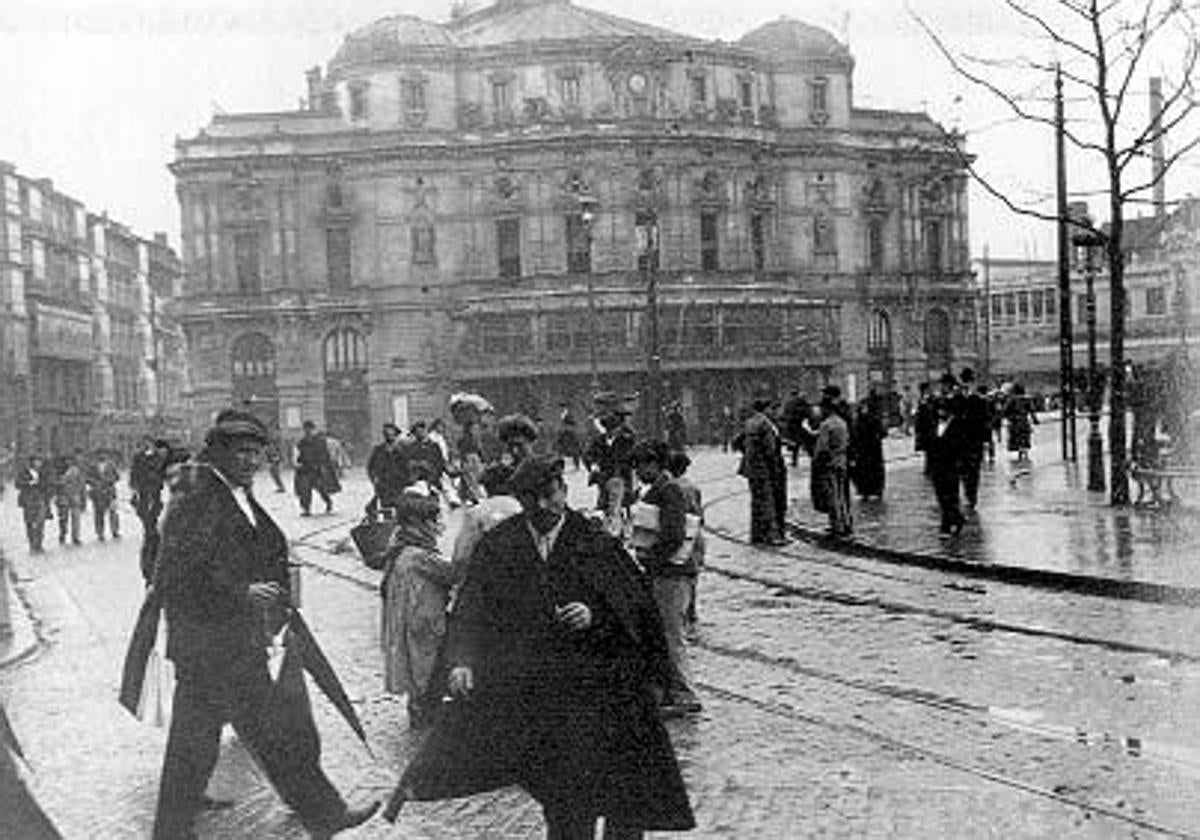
[382,490,460,728]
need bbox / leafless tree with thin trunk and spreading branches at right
[916,0,1200,505]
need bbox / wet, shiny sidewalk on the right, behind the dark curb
[790,422,1200,597]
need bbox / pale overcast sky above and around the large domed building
[0,0,1198,257]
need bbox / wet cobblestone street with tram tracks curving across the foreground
[0,429,1200,840]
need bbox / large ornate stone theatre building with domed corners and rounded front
[173,0,976,451]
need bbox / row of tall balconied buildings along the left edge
[0,157,188,454]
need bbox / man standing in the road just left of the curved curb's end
[734,395,787,546]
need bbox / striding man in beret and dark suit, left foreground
[152,409,378,840]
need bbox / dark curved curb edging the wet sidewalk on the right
[787,522,1200,607]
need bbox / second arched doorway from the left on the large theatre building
[323,326,371,461]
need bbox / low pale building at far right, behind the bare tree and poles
[974,198,1200,394]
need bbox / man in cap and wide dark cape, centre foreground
[385,456,695,840]
